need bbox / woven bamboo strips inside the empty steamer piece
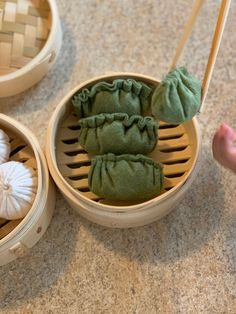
[0,0,51,75]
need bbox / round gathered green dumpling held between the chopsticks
[151,67,201,124]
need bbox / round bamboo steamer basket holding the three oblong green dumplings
[46,73,200,228]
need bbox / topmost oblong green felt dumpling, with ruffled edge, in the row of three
[72,79,152,118]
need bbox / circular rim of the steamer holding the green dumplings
[46,72,200,211]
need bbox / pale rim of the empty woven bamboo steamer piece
[0,0,59,83]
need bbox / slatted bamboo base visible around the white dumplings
[0,129,37,240]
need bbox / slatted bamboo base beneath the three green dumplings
[56,111,195,205]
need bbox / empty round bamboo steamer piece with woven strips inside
[0,0,62,98]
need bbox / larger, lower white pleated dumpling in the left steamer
[0,161,37,220]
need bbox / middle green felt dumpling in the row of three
[79,113,158,155]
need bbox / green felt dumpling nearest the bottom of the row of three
[88,154,164,201]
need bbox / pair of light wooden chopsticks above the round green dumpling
[170,0,231,112]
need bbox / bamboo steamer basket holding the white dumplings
[0,114,55,266]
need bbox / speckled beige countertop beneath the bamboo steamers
[0,0,236,314]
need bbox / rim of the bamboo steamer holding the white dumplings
[0,114,49,249]
